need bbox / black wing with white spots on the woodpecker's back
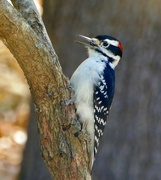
[93,63,115,157]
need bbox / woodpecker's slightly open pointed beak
[75,35,99,47]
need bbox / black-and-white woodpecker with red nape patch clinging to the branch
[70,35,123,165]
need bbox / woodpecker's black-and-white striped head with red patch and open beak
[76,35,123,68]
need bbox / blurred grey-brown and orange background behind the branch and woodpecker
[0,0,161,180]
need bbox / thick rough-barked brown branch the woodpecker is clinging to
[0,0,91,179]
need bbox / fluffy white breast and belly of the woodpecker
[70,56,105,138]
